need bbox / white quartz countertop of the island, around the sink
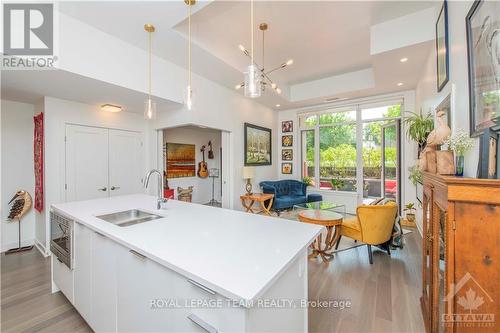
[52,194,322,301]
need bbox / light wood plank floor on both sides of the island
[0,229,424,333]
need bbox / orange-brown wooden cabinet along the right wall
[420,172,500,333]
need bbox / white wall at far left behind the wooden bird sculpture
[1,100,35,252]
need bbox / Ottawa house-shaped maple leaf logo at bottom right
[442,273,495,327]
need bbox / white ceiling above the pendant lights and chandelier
[29,1,439,109]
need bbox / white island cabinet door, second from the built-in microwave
[90,232,119,333]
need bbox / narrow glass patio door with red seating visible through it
[382,120,401,207]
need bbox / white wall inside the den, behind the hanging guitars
[163,126,221,204]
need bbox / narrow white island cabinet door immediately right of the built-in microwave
[73,223,93,322]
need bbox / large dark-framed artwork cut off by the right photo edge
[465,0,500,136]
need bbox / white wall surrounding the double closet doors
[36,97,148,250]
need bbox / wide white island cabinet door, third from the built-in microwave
[117,246,174,332]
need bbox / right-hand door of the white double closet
[109,130,144,196]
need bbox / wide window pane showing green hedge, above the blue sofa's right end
[319,124,356,192]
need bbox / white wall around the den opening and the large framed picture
[151,74,278,210]
